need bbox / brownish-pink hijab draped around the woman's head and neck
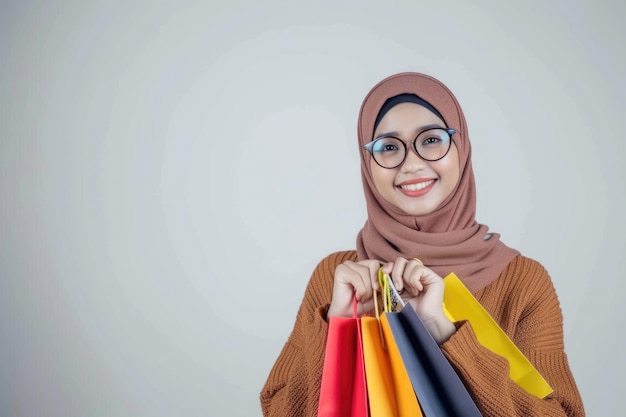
[357,73,519,292]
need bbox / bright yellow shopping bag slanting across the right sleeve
[443,274,552,398]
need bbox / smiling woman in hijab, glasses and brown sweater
[261,73,584,417]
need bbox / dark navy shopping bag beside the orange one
[381,304,482,417]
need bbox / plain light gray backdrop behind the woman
[0,0,626,417]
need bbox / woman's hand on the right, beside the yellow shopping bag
[383,258,456,344]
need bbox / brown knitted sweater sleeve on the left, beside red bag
[260,251,356,417]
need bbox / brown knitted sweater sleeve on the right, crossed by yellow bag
[442,256,585,417]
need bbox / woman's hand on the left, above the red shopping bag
[326,260,382,317]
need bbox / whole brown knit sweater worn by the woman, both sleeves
[261,251,585,417]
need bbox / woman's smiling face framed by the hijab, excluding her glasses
[370,103,459,216]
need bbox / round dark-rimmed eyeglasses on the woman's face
[363,128,456,169]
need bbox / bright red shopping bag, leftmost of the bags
[317,298,368,417]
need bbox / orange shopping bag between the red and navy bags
[361,293,422,417]
